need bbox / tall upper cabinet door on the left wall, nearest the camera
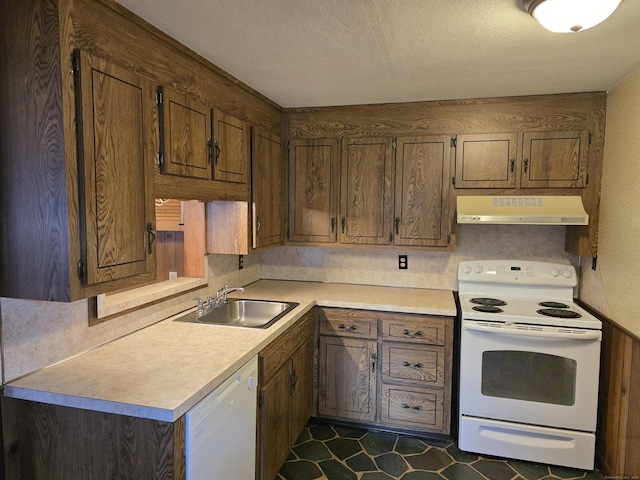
[76,52,155,286]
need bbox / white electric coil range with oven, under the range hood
[458,260,602,470]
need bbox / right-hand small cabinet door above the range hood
[521,130,589,188]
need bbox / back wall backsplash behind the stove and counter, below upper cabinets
[262,225,570,290]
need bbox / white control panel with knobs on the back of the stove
[458,260,577,287]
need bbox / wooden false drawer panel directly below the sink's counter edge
[260,309,316,384]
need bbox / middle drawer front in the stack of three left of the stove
[380,342,445,387]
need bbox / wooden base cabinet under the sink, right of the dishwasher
[256,309,316,480]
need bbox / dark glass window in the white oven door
[481,350,577,406]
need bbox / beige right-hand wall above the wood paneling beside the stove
[580,66,640,337]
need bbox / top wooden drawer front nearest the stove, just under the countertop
[381,314,444,345]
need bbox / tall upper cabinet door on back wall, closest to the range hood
[393,135,451,247]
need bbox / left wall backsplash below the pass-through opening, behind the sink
[0,254,260,382]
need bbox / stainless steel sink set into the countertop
[176,299,299,328]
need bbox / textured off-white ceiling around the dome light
[118,0,640,107]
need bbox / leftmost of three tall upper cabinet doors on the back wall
[288,138,340,243]
